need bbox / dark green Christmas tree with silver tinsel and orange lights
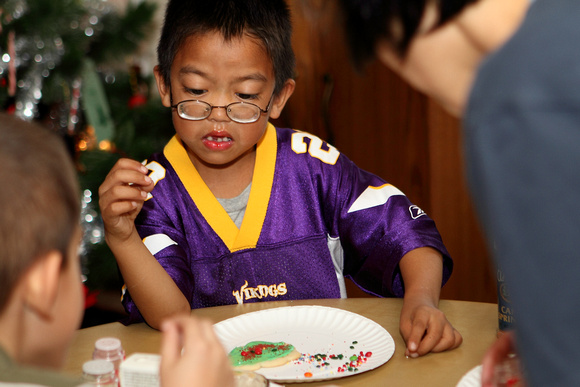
[0,0,173,300]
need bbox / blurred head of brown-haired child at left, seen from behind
[0,114,83,367]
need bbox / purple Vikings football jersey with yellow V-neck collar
[123,125,453,322]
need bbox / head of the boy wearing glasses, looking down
[155,0,295,170]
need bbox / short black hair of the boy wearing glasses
[157,0,295,94]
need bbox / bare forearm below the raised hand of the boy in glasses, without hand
[107,232,191,329]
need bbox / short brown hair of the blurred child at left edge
[0,113,80,313]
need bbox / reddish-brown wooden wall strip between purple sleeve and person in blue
[428,102,497,302]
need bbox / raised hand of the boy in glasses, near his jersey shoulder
[99,159,154,241]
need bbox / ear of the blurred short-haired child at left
[24,250,63,319]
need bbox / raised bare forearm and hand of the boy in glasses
[99,159,191,329]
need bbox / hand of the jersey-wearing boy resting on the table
[399,298,463,358]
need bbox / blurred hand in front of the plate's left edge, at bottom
[160,315,234,387]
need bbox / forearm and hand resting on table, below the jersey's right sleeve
[399,247,463,357]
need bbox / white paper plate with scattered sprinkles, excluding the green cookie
[214,306,395,383]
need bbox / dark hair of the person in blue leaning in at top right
[339,0,477,66]
